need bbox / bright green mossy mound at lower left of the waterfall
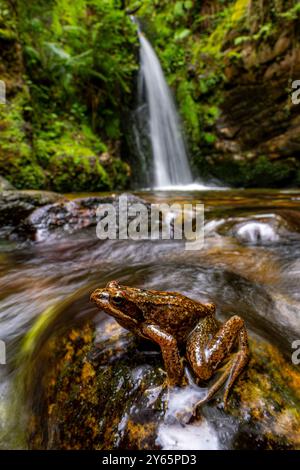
[34,121,130,192]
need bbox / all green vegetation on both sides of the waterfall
[0,0,300,191]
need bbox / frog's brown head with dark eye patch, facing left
[91,281,144,330]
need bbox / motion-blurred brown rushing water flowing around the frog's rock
[0,191,300,448]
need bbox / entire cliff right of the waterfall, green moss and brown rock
[140,0,300,187]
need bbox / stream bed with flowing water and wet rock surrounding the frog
[0,190,300,449]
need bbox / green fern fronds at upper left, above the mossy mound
[19,0,137,138]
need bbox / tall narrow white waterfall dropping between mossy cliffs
[138,30,193,188]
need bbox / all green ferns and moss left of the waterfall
[0,0,138,191]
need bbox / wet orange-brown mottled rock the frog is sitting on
[29,319,300,449]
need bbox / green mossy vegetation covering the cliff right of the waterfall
[135,0,300,187]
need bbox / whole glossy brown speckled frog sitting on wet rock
[90,280,250,413]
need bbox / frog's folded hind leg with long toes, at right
[187,315,249,407]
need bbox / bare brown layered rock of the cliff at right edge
[212,2,300,185]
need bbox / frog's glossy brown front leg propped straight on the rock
[142,324,184,385]
